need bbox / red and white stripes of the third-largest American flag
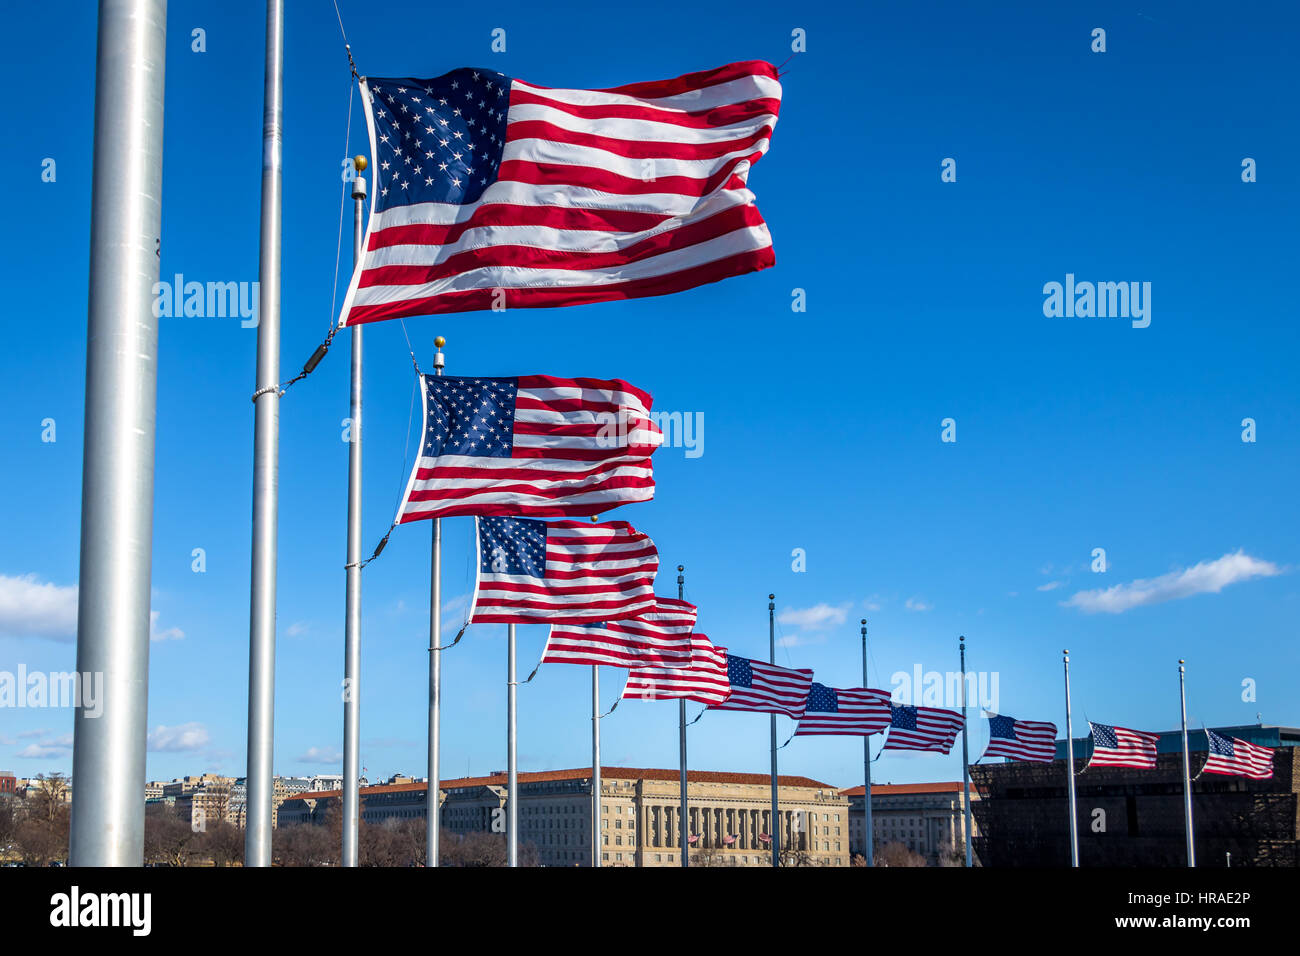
[469,522,659,624]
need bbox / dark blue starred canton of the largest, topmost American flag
[368,68,510,211]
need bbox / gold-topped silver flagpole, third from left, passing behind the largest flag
[342,156,365,866]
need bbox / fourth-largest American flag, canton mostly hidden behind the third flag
[542,597,696,667]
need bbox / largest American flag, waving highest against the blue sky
[339,61,781,325]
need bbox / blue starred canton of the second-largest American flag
[421,375,519,458]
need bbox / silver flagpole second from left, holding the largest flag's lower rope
[244,0,285,866]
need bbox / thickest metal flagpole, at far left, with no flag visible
[70,0,166,866]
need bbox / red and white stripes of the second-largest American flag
[398,375,663,523]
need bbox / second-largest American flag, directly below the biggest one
[398,375,663,523]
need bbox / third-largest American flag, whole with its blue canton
[469,518,659,624]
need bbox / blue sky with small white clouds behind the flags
[0,0,1300,786]
